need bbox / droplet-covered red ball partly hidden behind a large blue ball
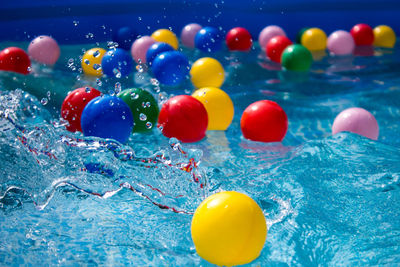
[61,87,101,132]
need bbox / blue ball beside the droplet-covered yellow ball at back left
[101,48,133,78]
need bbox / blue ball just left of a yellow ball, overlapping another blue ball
[152,51,189,85]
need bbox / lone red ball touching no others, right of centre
[240,100,288,142]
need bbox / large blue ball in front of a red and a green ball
[81,96,133,143]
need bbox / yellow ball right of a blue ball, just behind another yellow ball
[190,57,225,88]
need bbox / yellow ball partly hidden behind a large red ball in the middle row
[192,87,234,131]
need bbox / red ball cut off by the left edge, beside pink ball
[0,47,31,74]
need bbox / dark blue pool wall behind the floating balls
[0,0,400,43]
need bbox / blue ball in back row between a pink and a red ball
[194,27,223,52]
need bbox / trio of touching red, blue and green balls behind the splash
[61,87,159,143]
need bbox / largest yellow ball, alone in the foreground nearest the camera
[191,191,267,266]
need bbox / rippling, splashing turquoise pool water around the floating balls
[0,40,400,266]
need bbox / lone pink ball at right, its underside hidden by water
[332,108,379,140]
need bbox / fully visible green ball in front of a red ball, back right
[282,44,313,71]
